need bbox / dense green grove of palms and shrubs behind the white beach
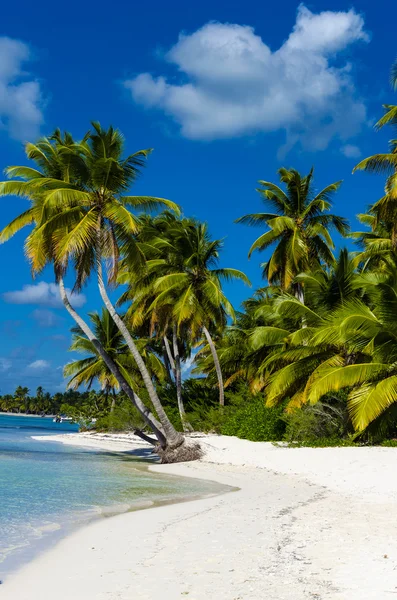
[0,62,397,460]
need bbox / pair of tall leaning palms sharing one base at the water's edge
[0,123,193,456]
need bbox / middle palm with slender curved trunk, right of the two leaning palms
[133,214,250,406]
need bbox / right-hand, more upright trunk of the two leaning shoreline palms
[97,248,184,448]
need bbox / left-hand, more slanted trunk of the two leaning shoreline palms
[58,277,167,448]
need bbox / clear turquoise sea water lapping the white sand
[0,414,222,579]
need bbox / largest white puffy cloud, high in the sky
[124,5,369,150]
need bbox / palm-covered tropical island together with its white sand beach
[0,28,397,600]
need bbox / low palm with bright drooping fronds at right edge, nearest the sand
[305,290,397,432]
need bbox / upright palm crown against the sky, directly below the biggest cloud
[237,168,349,301]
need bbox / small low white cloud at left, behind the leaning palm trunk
[3,281,86,308]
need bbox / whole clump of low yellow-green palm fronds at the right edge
[256,266,397,432]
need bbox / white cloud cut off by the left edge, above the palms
[0,37,43,140]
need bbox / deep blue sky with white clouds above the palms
[0,0,397,393]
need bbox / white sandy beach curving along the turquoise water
[0,434,397,600]
